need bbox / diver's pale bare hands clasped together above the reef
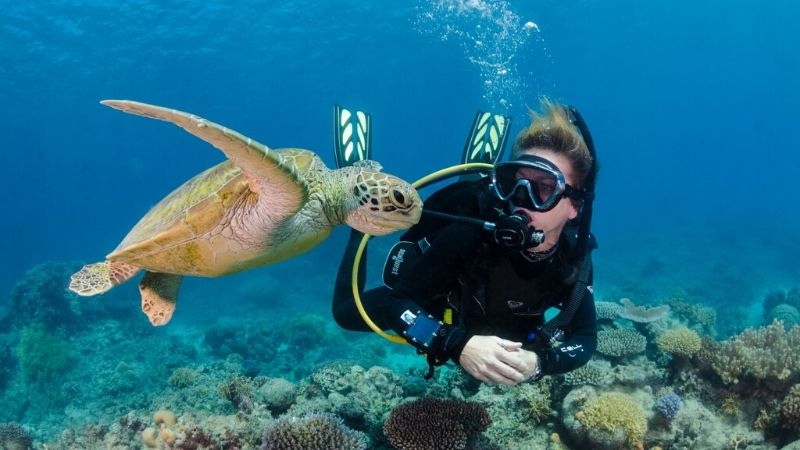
[458,336,536,385]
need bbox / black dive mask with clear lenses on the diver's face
[492,155,581,212]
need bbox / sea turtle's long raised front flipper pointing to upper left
[100,100,308,205]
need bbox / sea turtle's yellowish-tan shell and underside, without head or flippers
[107,149,328,276]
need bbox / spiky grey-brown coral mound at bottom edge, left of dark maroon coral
[261,414,367,450]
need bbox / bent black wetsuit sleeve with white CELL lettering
[536,288,597,375]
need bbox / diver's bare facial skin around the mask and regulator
[513,147,578,251]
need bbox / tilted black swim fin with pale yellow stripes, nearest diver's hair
[461,111,511,164]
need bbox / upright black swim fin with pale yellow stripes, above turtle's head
[333,105,372,168]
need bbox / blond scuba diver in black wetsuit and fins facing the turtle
[333,98,597,385]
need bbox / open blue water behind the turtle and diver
[0,0,800,446]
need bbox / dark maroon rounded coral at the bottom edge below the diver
[383,398,492,450]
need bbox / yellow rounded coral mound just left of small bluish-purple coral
[575,392,647,447]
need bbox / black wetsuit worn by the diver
[333,218,597,375]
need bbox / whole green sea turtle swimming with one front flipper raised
[69,100,422,325]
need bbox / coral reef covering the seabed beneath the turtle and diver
[0,264,800,449]
